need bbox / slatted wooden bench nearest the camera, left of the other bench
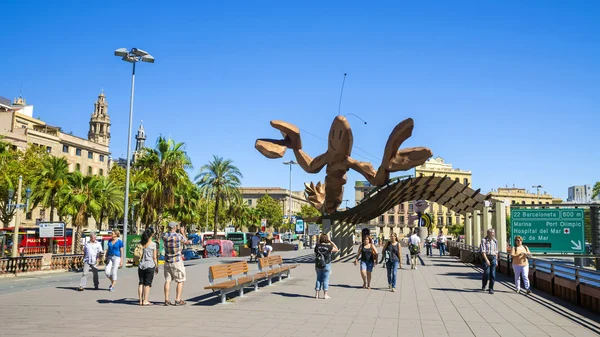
[204,261,268,304]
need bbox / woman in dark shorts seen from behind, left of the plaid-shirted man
[138,227,158,305]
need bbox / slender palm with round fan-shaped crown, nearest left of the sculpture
[196,155,242,237]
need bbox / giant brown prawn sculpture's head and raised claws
[254,116,432,214]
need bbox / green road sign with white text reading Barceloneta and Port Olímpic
[510,208,585,253]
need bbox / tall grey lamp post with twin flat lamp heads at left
[115,48,154,252]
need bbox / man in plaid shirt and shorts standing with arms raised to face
[162,221,191,305]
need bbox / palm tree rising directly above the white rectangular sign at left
[31,156,69,221]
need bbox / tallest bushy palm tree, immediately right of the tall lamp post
[136,137,192,231]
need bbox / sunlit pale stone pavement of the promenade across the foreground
[0,250,600,337]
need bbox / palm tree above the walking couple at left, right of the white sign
[63,171,102,252]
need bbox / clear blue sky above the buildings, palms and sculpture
[0,1,600,202]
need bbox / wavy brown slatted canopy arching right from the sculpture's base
[306,174,491,224]
